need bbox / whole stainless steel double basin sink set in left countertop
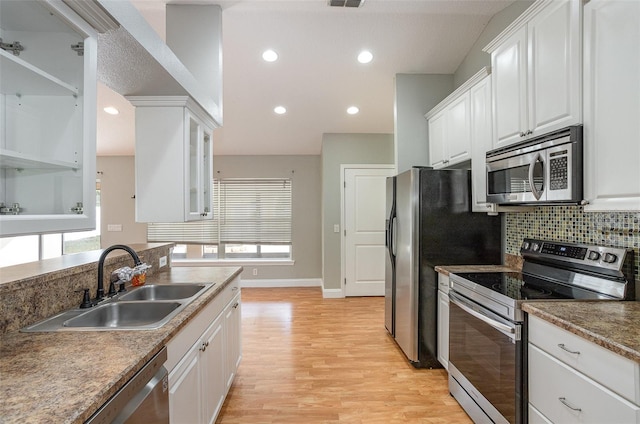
[21,283,214,332]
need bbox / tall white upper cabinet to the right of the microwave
[583,0,640,211]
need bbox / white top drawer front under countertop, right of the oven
[529,315,640,405]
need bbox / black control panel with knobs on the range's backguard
[520,239,630,270]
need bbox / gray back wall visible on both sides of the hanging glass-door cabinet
[97,155,322,279]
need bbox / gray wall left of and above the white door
[322,134,394,289]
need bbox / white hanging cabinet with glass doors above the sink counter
[127,96,215,222]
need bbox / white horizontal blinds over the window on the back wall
[147,178,292,244]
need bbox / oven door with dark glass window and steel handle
[449,292,523,424]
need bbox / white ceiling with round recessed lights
[97,0,513,156]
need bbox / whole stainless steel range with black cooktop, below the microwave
[449,239,635,423]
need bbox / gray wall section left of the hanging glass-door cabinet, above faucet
[96,156,147,249]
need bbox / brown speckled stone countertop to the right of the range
[522,301,640,362]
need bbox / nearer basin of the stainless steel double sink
[62,302,182,329]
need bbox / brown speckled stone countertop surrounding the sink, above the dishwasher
[0,267,242,424]
